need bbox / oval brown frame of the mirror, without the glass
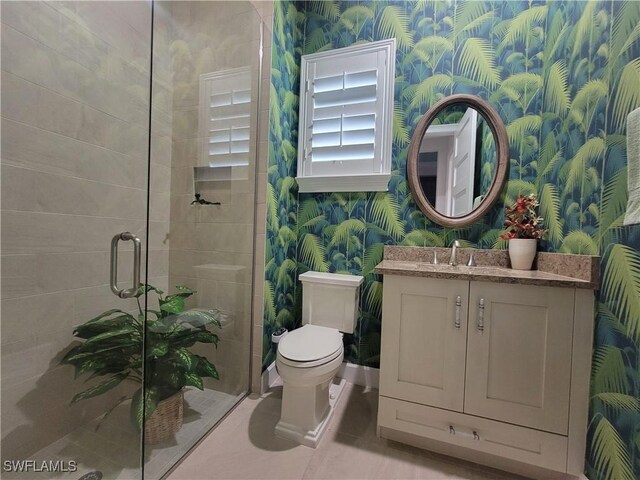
[407,94,509,228]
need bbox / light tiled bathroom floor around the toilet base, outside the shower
[168,384,525,480]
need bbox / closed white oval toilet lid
[278,325,342,362]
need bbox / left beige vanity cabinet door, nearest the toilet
[380,275,469,412]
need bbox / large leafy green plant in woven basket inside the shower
[61,285,220,443]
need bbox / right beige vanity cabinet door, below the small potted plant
[464,282,575,435]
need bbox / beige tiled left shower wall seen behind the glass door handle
[1,2,172,459]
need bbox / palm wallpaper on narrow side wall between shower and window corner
[262,1,302,370]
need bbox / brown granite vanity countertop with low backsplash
[375,246,598,289]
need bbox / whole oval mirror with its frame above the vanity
[407,95,509,228]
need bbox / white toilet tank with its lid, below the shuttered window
[298,272,364,333]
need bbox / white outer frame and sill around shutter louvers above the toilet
[296,38,396,192]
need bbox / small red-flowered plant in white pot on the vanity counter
[500,194,546,270]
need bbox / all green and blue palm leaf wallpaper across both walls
[263,0,640,480]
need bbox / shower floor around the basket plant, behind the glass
[2,390,244,480]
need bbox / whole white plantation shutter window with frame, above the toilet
[296,39,396,192]
